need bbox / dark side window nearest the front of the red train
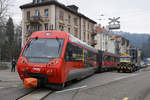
[65,43,83,61]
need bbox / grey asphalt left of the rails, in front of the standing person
[0,69,33,100]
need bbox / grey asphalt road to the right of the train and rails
[45,70,150,100]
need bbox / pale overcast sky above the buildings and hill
[8,0,150,34]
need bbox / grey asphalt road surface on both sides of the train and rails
[0,69,150,100]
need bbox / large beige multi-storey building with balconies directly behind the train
[20,0,96,46]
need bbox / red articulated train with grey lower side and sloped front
[17,31,118,90]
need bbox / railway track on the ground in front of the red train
[16,89,53,100]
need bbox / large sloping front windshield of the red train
[22,38,64,63]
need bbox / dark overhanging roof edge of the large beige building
[20,0,96,24]
